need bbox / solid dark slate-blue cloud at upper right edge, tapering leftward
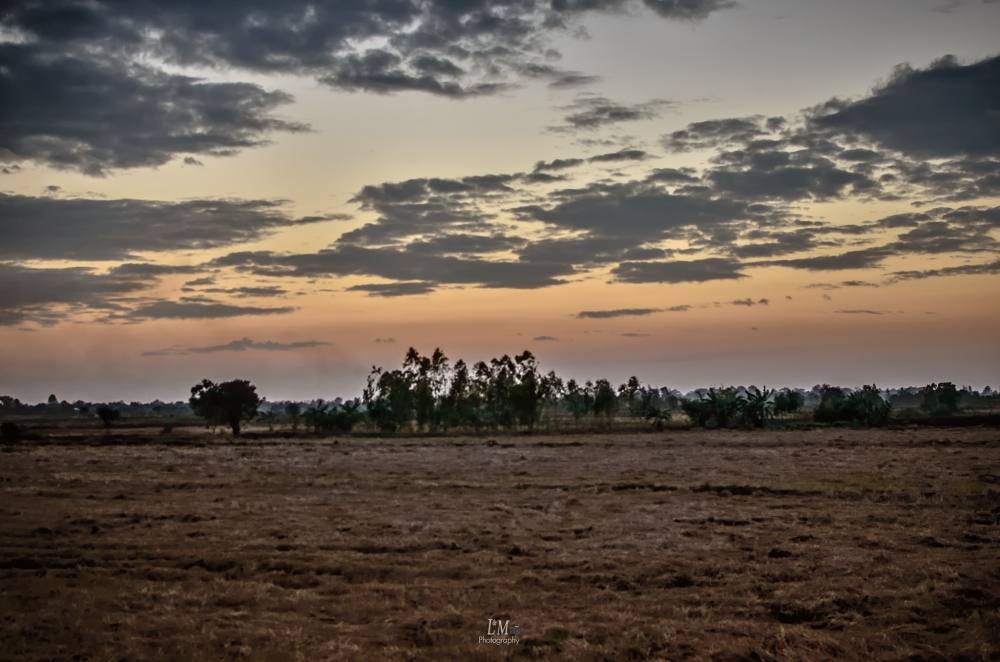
[809,56,1000,158]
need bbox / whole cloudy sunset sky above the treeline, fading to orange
[0,0,1000,401]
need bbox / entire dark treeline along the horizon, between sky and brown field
[0,348,1000,434]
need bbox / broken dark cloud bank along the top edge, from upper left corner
[0,0,732,121]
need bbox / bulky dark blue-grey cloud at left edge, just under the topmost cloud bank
[0,42,307,176]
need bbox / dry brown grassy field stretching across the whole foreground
[0,428,1000,660]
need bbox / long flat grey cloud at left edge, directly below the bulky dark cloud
[0,193,330,260]
